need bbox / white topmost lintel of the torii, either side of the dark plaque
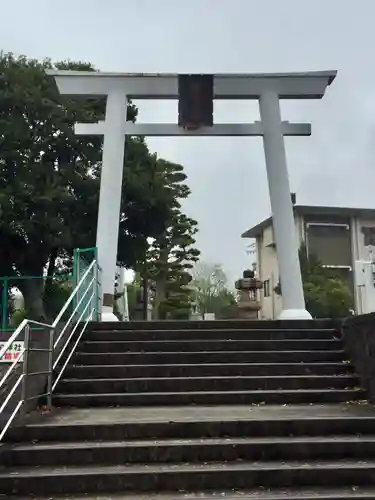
[47,70,337,99]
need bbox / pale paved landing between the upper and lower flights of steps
[22,402,375,425]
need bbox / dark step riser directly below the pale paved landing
[7,414,375,442]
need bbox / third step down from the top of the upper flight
[78,339,342,353]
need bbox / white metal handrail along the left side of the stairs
[0,260,101,441]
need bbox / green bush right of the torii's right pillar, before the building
[275,245,353,318]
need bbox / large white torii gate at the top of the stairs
[48,71,336,321]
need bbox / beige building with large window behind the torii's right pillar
[242,205,375,319]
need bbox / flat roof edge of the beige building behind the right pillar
[241,205,375,238]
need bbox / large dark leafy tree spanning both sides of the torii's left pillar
[0,53,182,319]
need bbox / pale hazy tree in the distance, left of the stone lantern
[191,261,237,319]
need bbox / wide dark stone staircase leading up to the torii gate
[0,321,375,500]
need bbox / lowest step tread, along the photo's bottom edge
[8,486,375,500]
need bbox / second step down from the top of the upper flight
[84,328,335,341]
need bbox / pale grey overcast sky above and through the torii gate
[0,0,375,279]
